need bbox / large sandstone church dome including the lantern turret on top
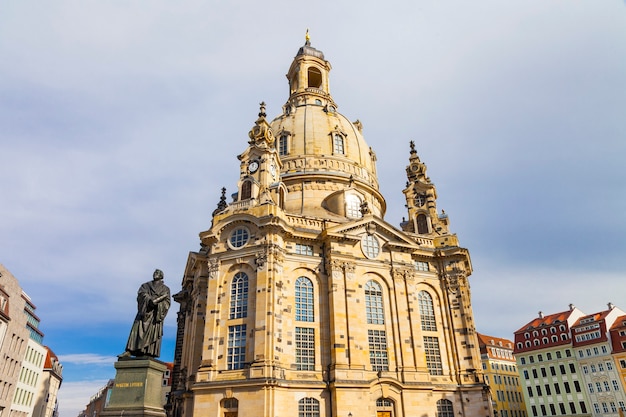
[271,39,386,218]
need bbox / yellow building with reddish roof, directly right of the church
[478,333,527,417]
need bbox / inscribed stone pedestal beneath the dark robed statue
[100,358,167,417]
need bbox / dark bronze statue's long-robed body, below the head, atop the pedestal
[126,280,171,358]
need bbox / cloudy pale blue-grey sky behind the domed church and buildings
[0,0,626,417]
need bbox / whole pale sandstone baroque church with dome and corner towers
[166,36,492,417]
